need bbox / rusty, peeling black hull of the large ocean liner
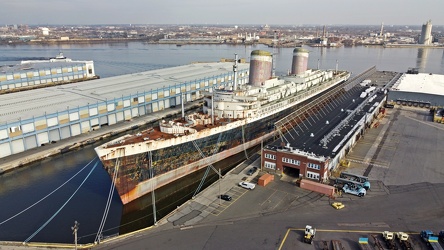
[96,72,350,204]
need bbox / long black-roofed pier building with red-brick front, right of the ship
[262,69,401,182]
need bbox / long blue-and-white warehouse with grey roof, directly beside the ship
[0,62,249,158]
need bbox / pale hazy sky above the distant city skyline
[0,0,444,25]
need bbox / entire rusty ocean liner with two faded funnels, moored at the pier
[95,48,350,204]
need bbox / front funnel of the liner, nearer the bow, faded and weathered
[249,50,273,86]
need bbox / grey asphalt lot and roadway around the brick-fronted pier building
[89,107,444,250]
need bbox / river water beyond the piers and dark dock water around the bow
[0,43,444,243]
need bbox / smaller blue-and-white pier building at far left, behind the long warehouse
[0,53,97,93]
